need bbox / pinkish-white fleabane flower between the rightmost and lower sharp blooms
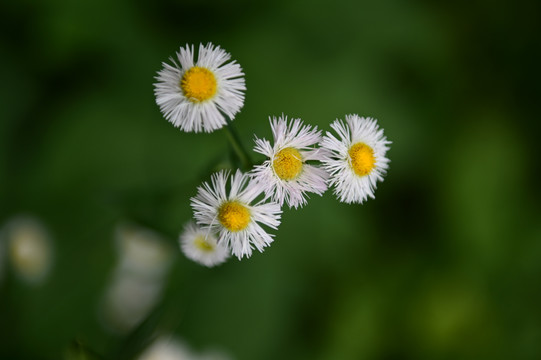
[251,116,328,208]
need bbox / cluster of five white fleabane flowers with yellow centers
[155,44,390,266]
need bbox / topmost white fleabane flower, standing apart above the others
[154,43,246,132]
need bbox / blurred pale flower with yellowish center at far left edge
[4,217,53,284]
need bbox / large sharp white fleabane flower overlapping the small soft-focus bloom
[191,170,282,260]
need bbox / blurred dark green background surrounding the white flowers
[0,0,541,360]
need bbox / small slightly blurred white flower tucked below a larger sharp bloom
[179,222,230,267]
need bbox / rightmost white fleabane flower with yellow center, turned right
[320,114,391,203]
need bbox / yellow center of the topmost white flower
[180,66,217,103]
